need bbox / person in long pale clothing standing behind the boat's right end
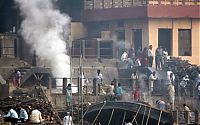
[168,84,175,110]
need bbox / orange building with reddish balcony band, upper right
[75,0,200,65]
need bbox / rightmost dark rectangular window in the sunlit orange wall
[178,29,192,56]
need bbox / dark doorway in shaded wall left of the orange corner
[132,29,142,51]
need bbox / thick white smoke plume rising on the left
[15,0,70,88]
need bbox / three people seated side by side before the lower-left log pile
[4,104,44,123]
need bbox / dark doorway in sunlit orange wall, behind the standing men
[158,29,172,55]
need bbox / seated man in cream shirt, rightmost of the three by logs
[30,109,44,123]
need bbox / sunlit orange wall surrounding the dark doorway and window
[148,19,200,65]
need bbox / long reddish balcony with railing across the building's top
[82,0,200,22]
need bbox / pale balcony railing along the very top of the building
[84,0,200,10]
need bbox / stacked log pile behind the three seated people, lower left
[0,96,60,124]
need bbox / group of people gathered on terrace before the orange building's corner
[121,45,169,70]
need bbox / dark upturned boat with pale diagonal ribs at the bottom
[83,101,173,125]
